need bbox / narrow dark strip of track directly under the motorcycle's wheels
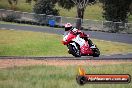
[0,56,132,61]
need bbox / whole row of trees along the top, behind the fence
[8,0,132,22]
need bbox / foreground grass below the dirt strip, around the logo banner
[0,64,132,88]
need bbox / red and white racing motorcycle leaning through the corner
[62,31,100,57]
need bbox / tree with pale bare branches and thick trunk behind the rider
[32,0,96,19]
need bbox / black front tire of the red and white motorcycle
[68,45,81,57]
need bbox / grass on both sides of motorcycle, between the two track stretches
[0,29,132,56]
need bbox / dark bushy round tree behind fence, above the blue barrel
[33,0,59,15]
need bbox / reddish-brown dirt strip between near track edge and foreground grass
[0,59,132,68]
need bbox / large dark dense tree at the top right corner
[101,0,132,22]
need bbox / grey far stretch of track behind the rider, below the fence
[0,24,132,44]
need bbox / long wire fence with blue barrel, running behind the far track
[0,9,132,33]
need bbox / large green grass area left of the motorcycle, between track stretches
[0,30,66,56]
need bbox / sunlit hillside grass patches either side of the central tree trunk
[56,3,103,20]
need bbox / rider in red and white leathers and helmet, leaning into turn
[65,23,95,48]
